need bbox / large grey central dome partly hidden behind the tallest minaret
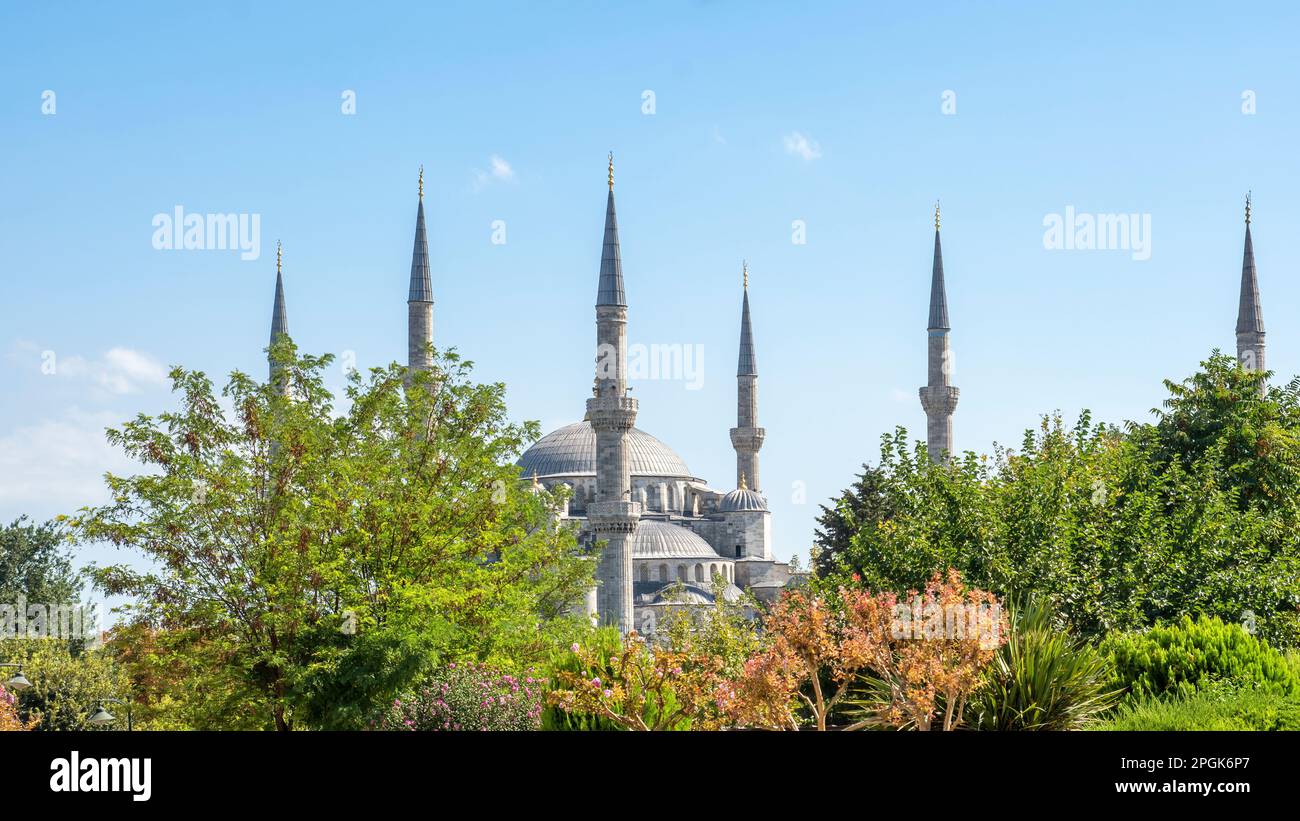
[519,422,694,479]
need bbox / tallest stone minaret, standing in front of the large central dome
[586,153,641,634]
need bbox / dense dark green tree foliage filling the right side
[820,352,1300,644]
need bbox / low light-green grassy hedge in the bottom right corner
[1096,686,1300,730]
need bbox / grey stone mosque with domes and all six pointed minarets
[263,163,1264,633]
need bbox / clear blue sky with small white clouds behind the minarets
[0,1,1300,605]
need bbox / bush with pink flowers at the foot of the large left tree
[371,663,546,731]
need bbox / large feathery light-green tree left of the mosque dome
[73,339,592,730]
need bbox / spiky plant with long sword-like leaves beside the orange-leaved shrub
[967,599,1123,730]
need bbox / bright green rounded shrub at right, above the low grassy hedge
[1101,616,1300,700]
